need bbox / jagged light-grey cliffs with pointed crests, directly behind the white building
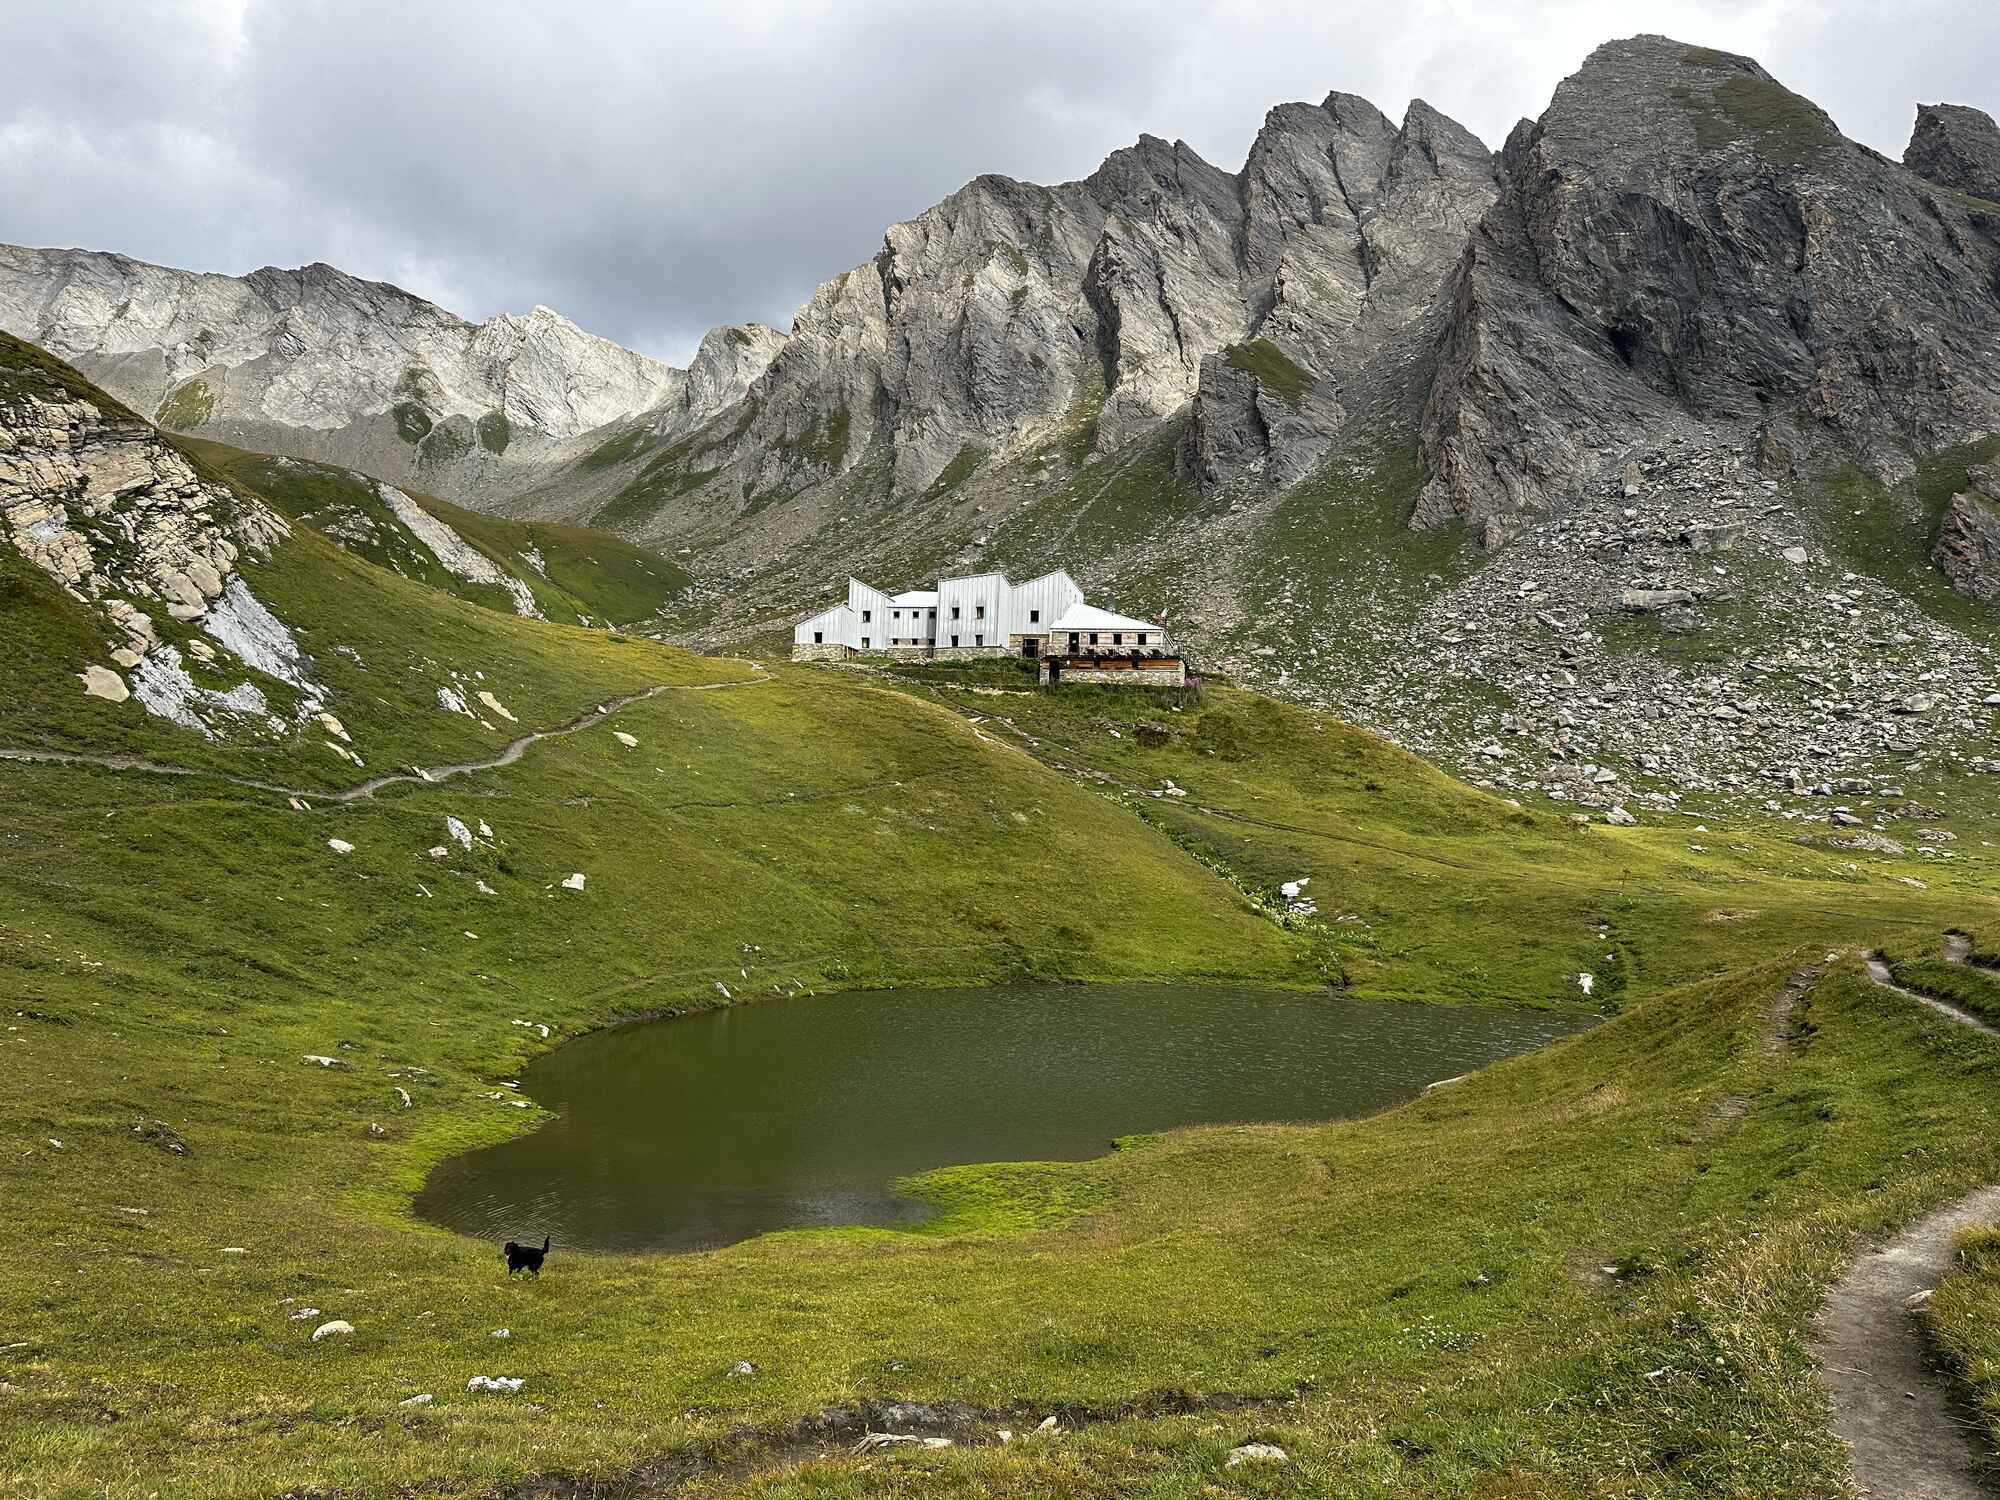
[680,94,1498,512]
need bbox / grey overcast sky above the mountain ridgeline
[0,0,2000,362]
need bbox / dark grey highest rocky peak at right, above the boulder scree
[1418,36,2000,544]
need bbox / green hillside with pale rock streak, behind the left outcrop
[178,438,690,624]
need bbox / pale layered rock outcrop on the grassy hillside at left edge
[0,334,322,736]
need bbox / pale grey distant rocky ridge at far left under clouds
[0,246,782,492]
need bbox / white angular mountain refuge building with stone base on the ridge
[792,568,1186,686]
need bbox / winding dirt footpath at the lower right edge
[1814,956,2000,1500]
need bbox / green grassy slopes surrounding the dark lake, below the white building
[0,340,2000,1496]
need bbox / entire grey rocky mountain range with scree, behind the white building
[0,36,2000,808]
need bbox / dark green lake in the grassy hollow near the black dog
[416,986,1588,1250]
